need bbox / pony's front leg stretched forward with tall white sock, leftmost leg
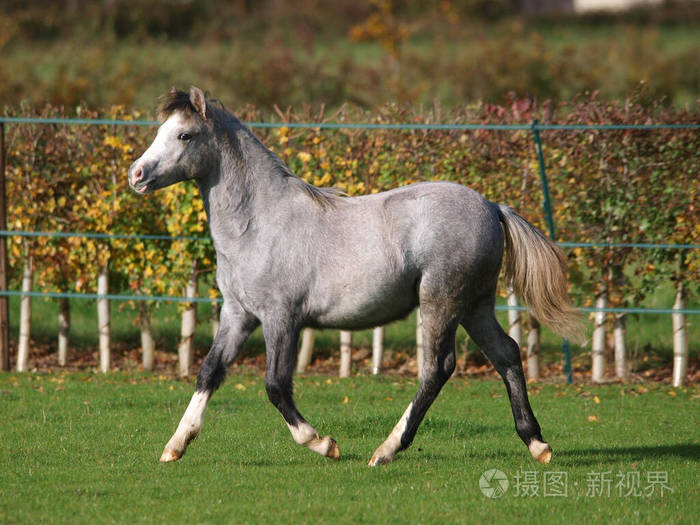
[160,303,259,463]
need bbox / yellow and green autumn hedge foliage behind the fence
[6,97,700,334]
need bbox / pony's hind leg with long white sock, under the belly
[369,305,457,467]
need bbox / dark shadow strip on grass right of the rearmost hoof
[553,443,700,465]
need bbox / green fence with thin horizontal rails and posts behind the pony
[0,117,700,376]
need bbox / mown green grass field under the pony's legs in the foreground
[0,374,700,524]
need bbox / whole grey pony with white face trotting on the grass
[129,87,581,466]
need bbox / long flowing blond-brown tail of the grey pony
[497,204,584,342]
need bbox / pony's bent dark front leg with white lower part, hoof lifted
[263,323,340,459]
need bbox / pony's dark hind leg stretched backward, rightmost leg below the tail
[462,303,552,464]
